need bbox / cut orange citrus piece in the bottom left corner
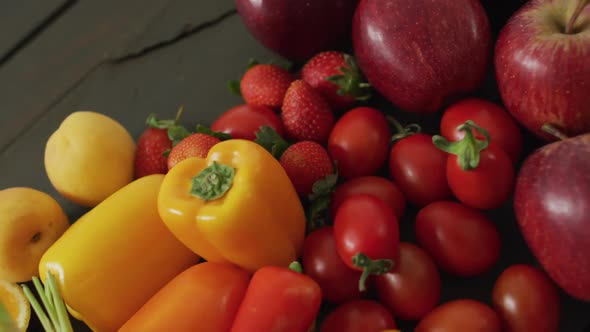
[0,280,31,331]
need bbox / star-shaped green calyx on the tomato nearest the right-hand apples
[432,120,491,171]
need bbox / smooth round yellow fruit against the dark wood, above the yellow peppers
[45,111,135,207]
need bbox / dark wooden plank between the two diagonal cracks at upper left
[0,0,233,151]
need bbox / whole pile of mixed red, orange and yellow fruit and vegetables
[0,0,590,332]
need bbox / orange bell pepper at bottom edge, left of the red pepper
[119,262,250,332]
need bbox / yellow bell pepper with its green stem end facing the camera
[158,139,306,272]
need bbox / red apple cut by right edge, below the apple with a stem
[514,127,590,301]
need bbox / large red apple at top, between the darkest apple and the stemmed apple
[352,0,492,113]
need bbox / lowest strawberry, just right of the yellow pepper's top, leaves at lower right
[279,141,334,196]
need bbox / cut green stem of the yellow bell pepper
[190,161,235,202]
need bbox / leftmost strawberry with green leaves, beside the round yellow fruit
[134,108,190,179]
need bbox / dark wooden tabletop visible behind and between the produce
[0,0,590,332]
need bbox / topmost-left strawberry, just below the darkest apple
[231,62,294,109]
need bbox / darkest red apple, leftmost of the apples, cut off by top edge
[236,0,358,61]
